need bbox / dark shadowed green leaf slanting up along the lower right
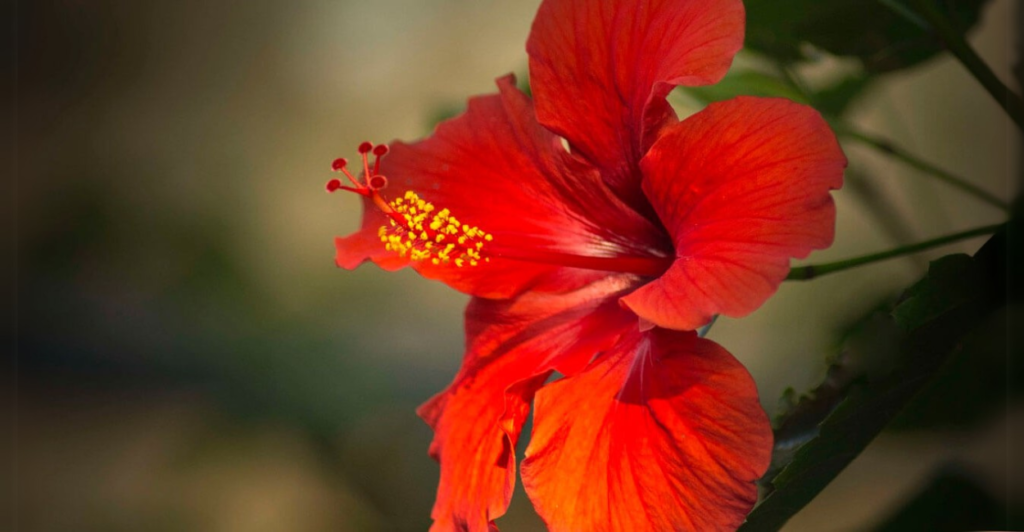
[740,225,1020,532]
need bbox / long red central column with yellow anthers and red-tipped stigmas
[327,142,673,277]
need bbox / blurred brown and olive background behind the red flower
[9,0,1024,532]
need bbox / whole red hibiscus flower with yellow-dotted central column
[328,0,846,531]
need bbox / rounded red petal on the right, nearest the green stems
[623,97,846,329]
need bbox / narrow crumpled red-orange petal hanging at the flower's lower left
[419,276,636,530]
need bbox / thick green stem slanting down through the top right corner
[913,0,1024,129]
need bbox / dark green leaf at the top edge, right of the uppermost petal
[744,0,987,73]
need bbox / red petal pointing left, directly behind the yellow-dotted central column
[338,76,670,298]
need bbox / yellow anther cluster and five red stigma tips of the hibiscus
[327,142,494,268]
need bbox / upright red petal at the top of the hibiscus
[526,0,743,205]
